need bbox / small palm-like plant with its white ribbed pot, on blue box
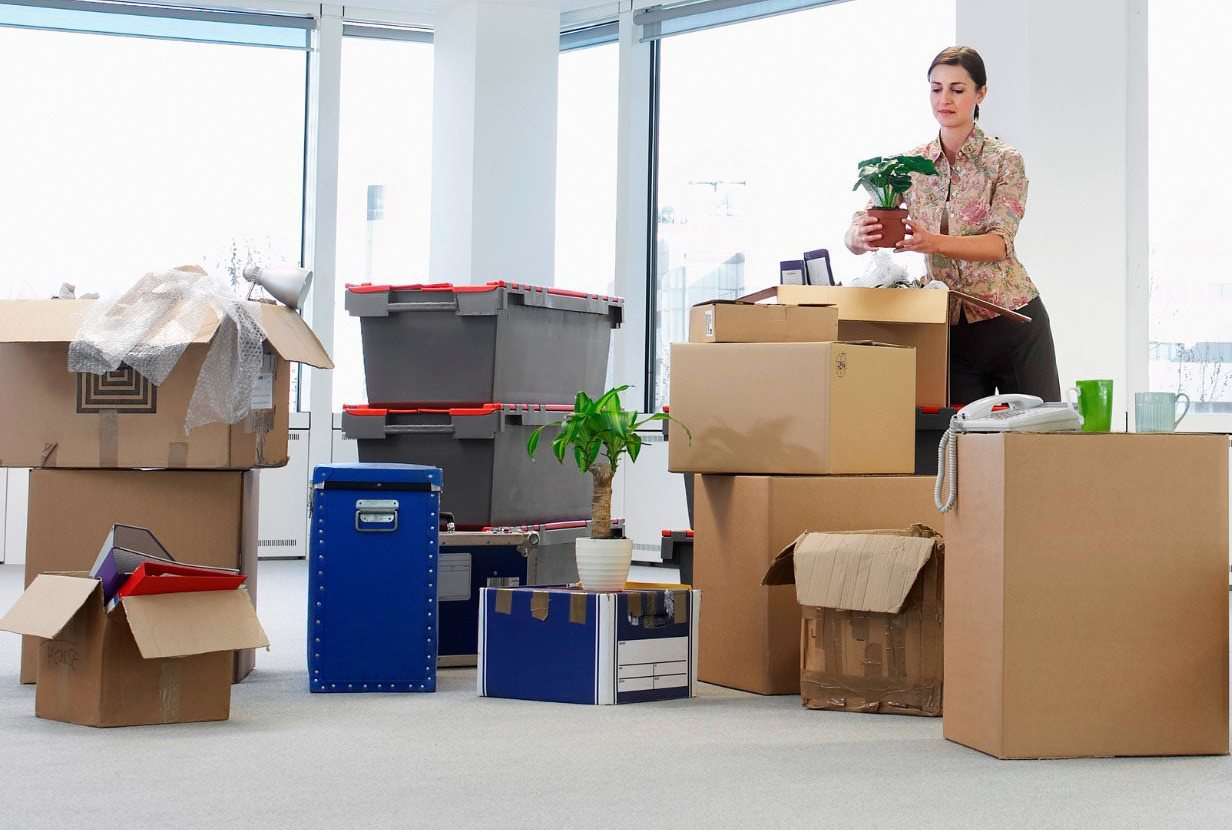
[526,385,692,591]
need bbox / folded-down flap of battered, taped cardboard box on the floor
[763,531,938,613]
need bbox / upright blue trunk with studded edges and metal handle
[308,464,441,692]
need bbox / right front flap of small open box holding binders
[122,590,270,660]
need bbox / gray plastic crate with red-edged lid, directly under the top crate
[342,404,593,530]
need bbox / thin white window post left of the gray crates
[304,6,342,475]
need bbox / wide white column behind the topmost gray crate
[429,0,561,284]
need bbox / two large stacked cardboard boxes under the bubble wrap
[0,299,331,720]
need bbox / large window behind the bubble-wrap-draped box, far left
[0,5,309,299]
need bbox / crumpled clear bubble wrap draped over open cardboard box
[68,266,265,435]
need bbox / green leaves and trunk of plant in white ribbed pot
[526,385,692,539]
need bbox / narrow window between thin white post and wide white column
[333,26,432,411]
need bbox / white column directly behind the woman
[957,0,1130,413]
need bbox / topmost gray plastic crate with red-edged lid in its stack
[346,282,625,406]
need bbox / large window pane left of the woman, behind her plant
[649,0,955,408]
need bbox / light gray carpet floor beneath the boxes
[0,562,1232,830]
